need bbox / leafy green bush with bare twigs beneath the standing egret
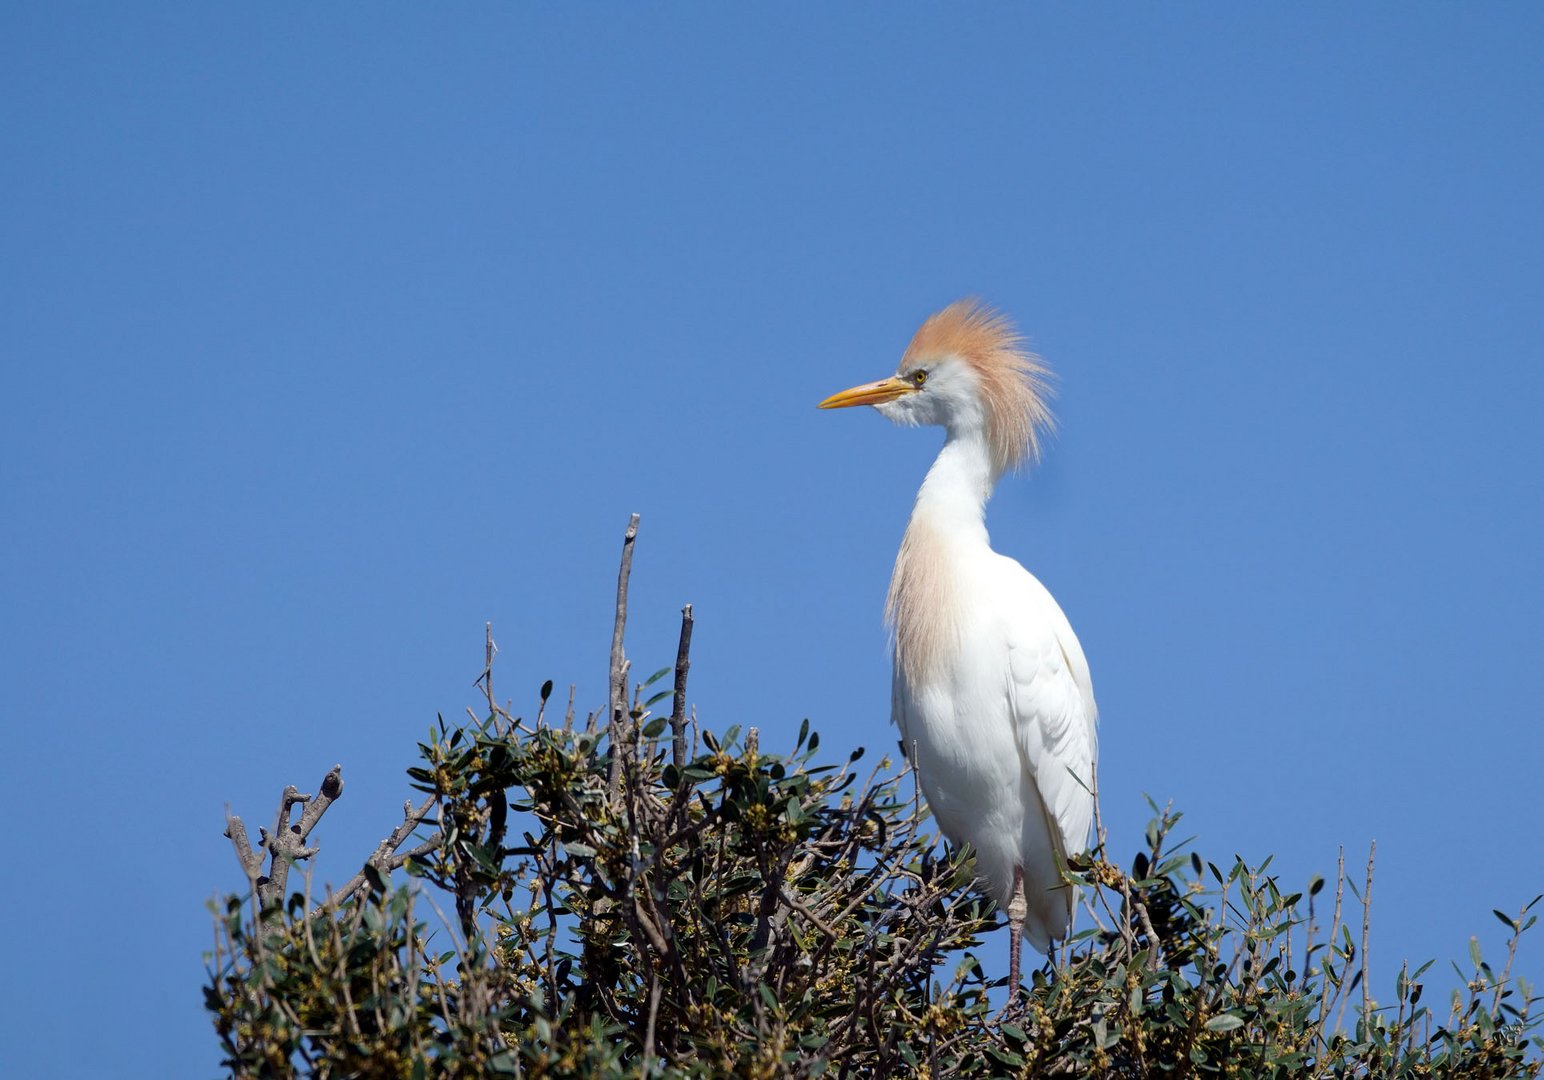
[204,519,1544,1078]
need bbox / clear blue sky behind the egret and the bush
[0,3,1544,1077]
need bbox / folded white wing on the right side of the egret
[1007,559,1099,856]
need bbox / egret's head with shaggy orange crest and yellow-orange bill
[820,300,1051,473]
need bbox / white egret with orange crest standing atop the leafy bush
[820,300,1098,995]
